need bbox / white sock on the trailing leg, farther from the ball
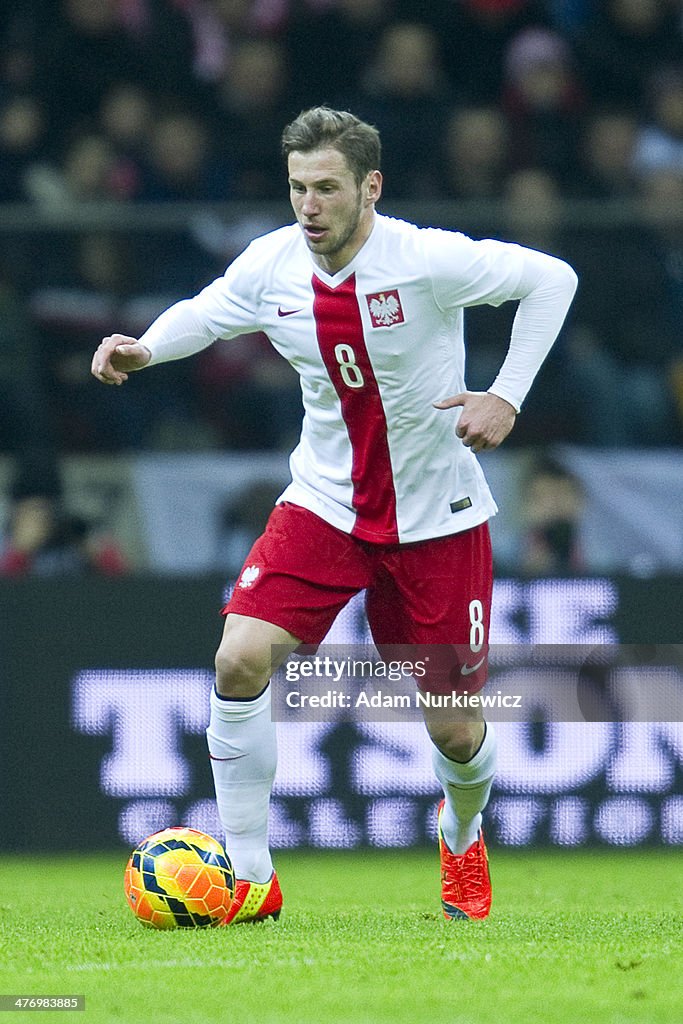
[432,722,497,854]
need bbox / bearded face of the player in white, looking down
[288,148,382,273]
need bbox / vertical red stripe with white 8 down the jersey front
[312,274,398,544]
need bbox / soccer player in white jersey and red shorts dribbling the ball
[92,106,577,923]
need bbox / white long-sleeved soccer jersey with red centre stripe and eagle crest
[140,215,575,544]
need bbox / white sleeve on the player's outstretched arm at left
[139,243,261,366]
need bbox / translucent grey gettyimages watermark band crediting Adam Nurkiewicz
[272,644,683,722]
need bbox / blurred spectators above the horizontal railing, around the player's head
[0,0,683,205]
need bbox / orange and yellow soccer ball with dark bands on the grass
[124,828,234,929]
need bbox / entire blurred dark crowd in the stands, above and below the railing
[0,0,683,577]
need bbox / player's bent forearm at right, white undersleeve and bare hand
[434,247,578,452]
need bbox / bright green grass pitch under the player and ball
[0,850,683,1024]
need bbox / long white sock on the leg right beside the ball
[207,686,278,882]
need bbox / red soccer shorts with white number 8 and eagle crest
[222,503,493,692]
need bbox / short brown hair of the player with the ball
[283,106,382,184]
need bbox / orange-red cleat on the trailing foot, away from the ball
[438,801,490,921]
